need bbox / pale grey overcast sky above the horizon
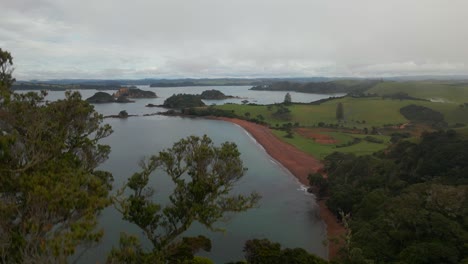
[0,0,468,80]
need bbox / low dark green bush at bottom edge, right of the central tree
[239,239,328,264]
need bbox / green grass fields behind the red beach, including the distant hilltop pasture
[215,82,468,159]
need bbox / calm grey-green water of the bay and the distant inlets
[22,87,326,263]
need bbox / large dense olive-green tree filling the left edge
[0,51,112,263]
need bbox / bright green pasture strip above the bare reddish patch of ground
[216,97,468,128]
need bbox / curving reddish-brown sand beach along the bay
[213,117,345,259]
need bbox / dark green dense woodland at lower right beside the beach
[324,131,468,263]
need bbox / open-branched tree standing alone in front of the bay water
[108,135,259,263]
